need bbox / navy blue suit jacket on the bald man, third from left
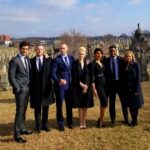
[52,55,74,90]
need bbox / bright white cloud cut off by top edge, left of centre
[34,0,78,9]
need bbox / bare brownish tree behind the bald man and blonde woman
[60,29,87,57]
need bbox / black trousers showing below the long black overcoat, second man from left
[34,105,49,129]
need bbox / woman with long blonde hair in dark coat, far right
[125,51,144,127]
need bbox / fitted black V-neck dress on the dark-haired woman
[92,60,108,107]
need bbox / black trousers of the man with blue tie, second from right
[108,81,128,122]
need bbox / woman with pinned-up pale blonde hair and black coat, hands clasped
[72,47,94,129]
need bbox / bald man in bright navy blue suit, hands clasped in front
[52,44,74,131]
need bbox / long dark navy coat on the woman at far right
[125,62,144,107]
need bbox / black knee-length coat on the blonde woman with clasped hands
[72,60,94,108]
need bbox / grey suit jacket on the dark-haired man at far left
[8,55,31,94]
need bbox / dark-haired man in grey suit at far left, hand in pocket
[8,41,32,143]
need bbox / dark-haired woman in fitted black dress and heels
[92,48,108,127]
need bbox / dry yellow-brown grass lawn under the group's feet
[0,82,150,150]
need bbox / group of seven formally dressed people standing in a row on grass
[8,41,144,143]
